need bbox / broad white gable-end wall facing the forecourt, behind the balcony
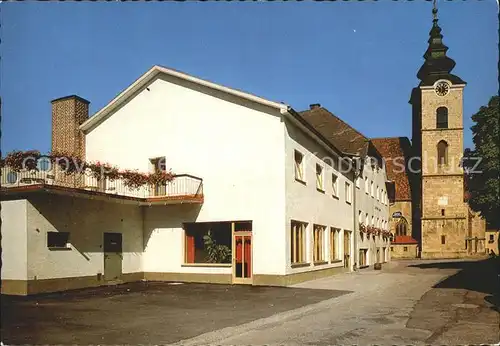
[86,77,286,274]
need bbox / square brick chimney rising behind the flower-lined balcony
[51,95,90,159]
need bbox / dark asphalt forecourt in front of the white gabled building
[1,282,347,345]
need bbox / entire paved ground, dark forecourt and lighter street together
[1,260,500,345]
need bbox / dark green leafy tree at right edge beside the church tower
[463,96,500,229]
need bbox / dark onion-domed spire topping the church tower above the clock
[417,0,465,85]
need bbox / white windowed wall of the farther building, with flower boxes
[356,158,390,265]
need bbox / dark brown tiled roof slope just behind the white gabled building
[299,107,369,157]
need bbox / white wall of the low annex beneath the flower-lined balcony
[27,194,143,280]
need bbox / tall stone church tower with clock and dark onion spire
[410,0,469,258]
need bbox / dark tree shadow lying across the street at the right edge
[410,257,500,311]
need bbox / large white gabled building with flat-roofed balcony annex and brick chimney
[2,66,364,294]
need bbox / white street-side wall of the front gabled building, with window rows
[283,121,355,274]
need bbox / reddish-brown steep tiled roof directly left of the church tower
[371,137,411,201]
